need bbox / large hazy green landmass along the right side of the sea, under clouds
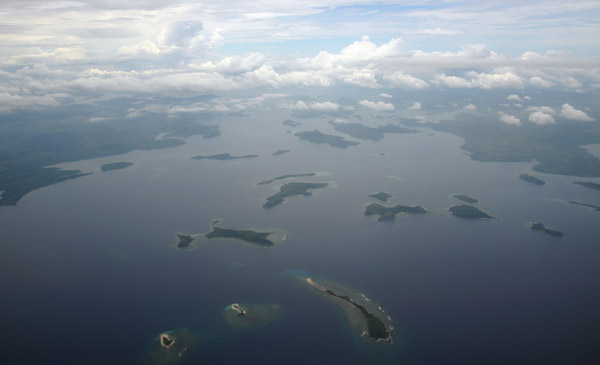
[414,113,600,177]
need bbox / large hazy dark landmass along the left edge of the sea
[0,111,220,206]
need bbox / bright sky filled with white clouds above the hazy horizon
[0,0,600,118]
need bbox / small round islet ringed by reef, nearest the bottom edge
[144,328,199,365]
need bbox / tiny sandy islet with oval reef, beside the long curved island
[223,303,283,330]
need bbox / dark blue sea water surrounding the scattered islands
[0,112,600,364]
